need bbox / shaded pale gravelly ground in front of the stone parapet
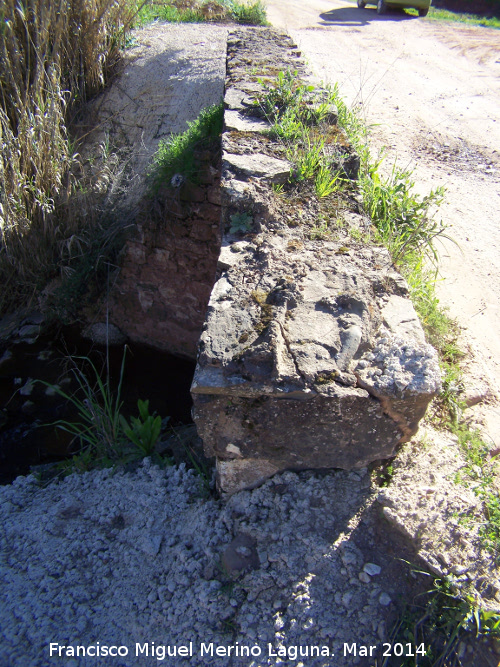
[0,459,396,667]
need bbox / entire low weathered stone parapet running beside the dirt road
[191,28,440,492]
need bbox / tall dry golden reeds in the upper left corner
[0,0,141,312]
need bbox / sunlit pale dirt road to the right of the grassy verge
[267,0,500,447]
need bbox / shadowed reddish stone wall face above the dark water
[110,152,221,359]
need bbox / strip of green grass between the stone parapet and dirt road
[335,85,500,560]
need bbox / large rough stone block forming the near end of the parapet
[191,236,440,492]
